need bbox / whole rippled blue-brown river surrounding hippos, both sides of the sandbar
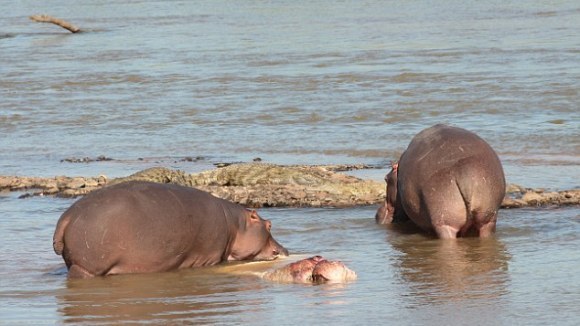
[0,0,580,325]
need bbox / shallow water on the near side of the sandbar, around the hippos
[0,196,580,325]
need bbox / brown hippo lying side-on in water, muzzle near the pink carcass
[53,181,288,278]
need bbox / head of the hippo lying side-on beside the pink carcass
[228,210,288,260]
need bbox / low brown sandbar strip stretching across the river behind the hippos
[0,163,580,208]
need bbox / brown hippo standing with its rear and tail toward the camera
[375,124,506,239]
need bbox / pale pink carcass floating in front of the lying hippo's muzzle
[262,256,357,283]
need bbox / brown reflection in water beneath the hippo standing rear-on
[389,234,511,304]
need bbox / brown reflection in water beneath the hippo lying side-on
[57,268,264,323]
